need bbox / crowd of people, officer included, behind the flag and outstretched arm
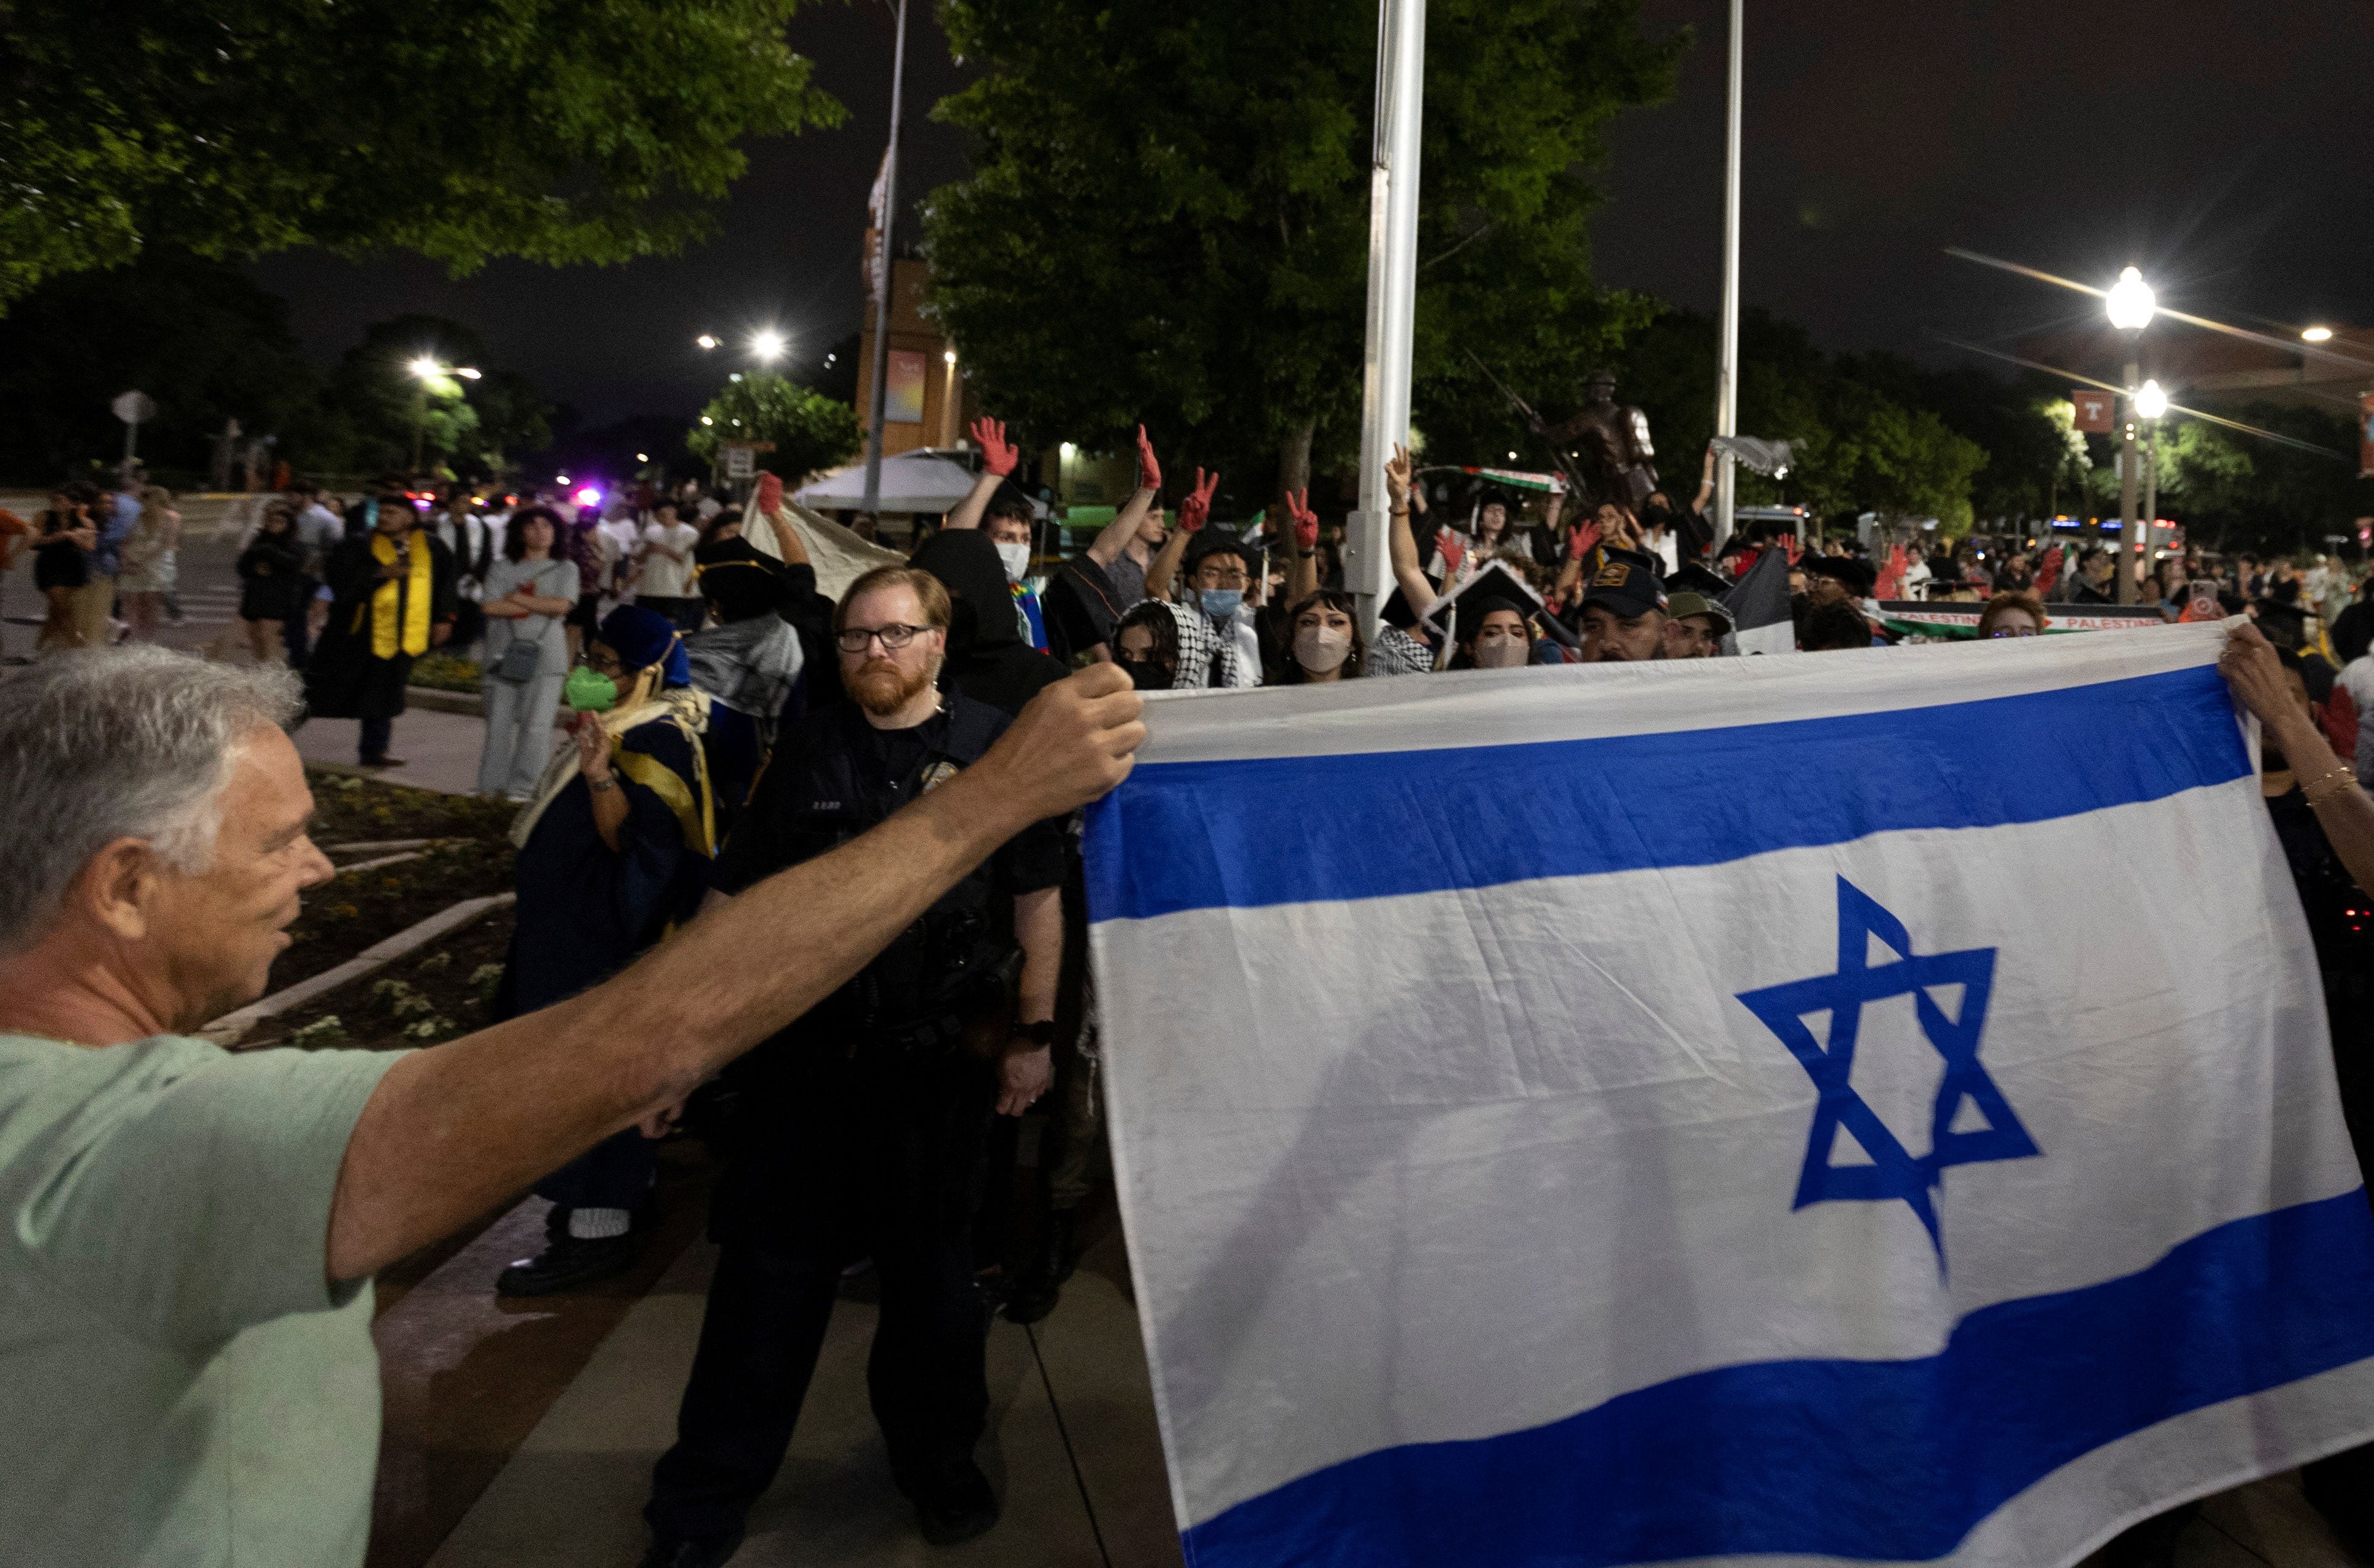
[4,420,2374,1568]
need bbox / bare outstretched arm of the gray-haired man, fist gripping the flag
[327,665,1146,1281]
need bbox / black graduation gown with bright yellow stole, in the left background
[304,527,456,718]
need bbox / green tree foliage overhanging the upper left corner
[0,0,843,309]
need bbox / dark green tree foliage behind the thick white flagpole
[926,0,1685,501]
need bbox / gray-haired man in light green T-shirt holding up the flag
[0,649,1145,1568]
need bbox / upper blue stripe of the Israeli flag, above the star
[1087,665,2250,919]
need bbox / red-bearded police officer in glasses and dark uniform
[644,566,1063,1568]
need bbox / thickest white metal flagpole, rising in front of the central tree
[1344,0,1427,641]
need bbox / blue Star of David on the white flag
[1738,877,2044,1266]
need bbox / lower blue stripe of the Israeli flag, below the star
[1182,1188,2374,1568]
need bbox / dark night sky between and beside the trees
[257,0,2374,423]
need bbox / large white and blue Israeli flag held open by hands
[1087,625,2374,1568]
